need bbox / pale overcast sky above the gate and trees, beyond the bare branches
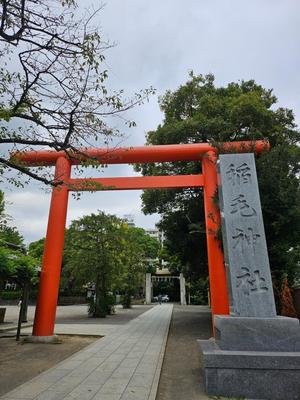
[5,0,300,243]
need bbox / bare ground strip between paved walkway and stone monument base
[156,305,212,400]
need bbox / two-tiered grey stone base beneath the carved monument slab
[198,315,300,400]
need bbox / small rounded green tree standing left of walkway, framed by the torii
[64,211,123,317]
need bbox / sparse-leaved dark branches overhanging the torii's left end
[0,0,153,184]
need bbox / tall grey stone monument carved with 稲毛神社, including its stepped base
[199,153,300,400]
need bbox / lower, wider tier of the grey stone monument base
[198,339,300,400]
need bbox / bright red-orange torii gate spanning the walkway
[14,141,269,336]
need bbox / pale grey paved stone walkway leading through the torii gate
[1,304,173,400]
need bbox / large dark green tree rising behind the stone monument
[136,73,300,290]
